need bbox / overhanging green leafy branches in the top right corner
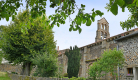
[105,0,138,31]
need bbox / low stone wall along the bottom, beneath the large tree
[7,72,68,80]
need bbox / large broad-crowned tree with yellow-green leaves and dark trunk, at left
[0,11,57,75]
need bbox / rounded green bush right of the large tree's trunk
[32,53,58,77]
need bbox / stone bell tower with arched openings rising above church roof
[95,18,110,42]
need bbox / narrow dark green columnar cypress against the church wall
[65,45,81,78]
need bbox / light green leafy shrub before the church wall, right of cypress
[88,48,125,80]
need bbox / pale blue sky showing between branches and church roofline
[0,0,133,50]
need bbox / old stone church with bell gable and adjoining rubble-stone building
[58,18,138,80]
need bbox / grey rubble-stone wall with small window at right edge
[118,36,138,80]
